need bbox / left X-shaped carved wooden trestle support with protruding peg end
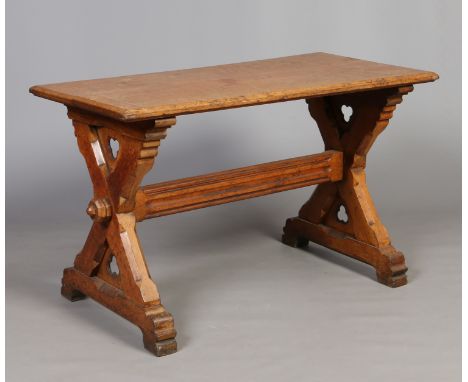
[58,111,177,356]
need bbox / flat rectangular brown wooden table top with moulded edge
[30,53,438,121]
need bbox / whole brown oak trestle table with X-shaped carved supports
[30,53,438,356]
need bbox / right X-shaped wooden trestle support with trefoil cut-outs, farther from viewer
[283,86,413,287]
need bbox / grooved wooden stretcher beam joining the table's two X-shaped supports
[135,151,343,221]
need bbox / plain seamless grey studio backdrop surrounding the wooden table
[6,0,461,381]
